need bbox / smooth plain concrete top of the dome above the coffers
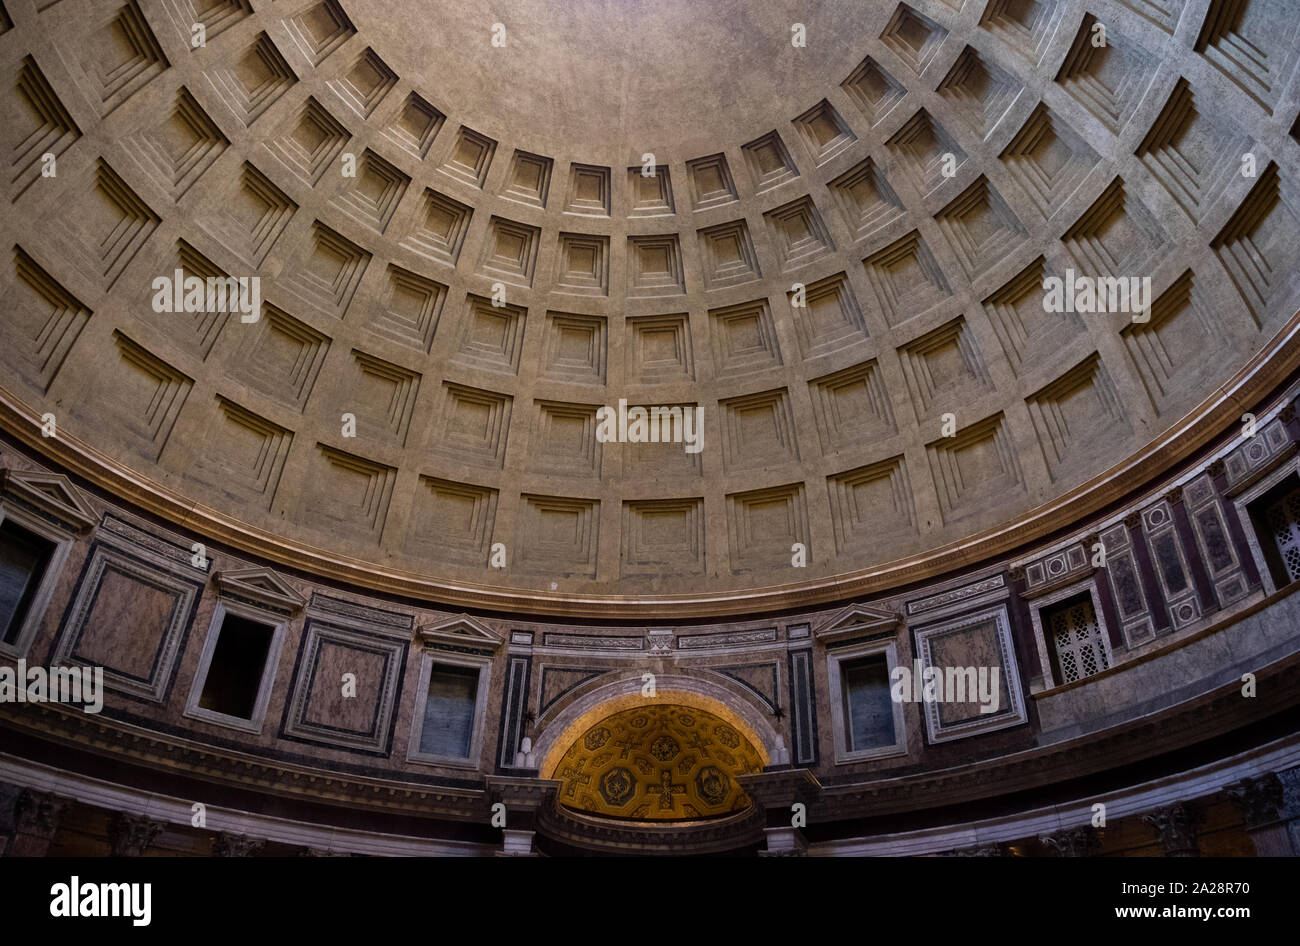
[345,0,868,165]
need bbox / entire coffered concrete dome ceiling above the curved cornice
[0,0,1300,613]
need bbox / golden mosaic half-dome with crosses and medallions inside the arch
[554,703,763,821]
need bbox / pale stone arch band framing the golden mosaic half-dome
[533,671,785,778]
